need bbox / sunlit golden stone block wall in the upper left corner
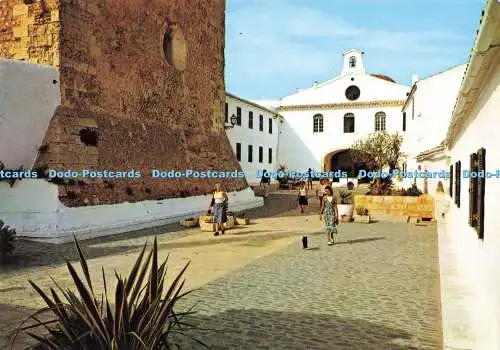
[0,0,60,66]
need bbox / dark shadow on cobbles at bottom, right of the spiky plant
[175,309,418,350]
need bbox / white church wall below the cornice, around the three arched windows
[279,107,403,171]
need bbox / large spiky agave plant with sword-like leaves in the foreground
[12,238,206,350]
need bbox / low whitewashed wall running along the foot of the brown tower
[0,179,264,243]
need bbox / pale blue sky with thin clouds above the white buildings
[225,0,486,99]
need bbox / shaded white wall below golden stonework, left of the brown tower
[0,58,61,169]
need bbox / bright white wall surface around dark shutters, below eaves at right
[440,56,500,350]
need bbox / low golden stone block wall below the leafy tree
[354,195,435,219]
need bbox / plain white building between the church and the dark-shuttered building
[401,64,466,194]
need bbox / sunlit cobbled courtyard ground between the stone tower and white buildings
[0,191,442,350]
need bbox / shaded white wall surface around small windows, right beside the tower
[226,96,280,185]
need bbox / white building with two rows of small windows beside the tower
[225,93,282,186]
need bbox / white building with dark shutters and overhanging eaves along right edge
[426,0,500,350]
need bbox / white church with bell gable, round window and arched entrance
[256,50,410,176]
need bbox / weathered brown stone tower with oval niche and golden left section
[0,0,247,206]
